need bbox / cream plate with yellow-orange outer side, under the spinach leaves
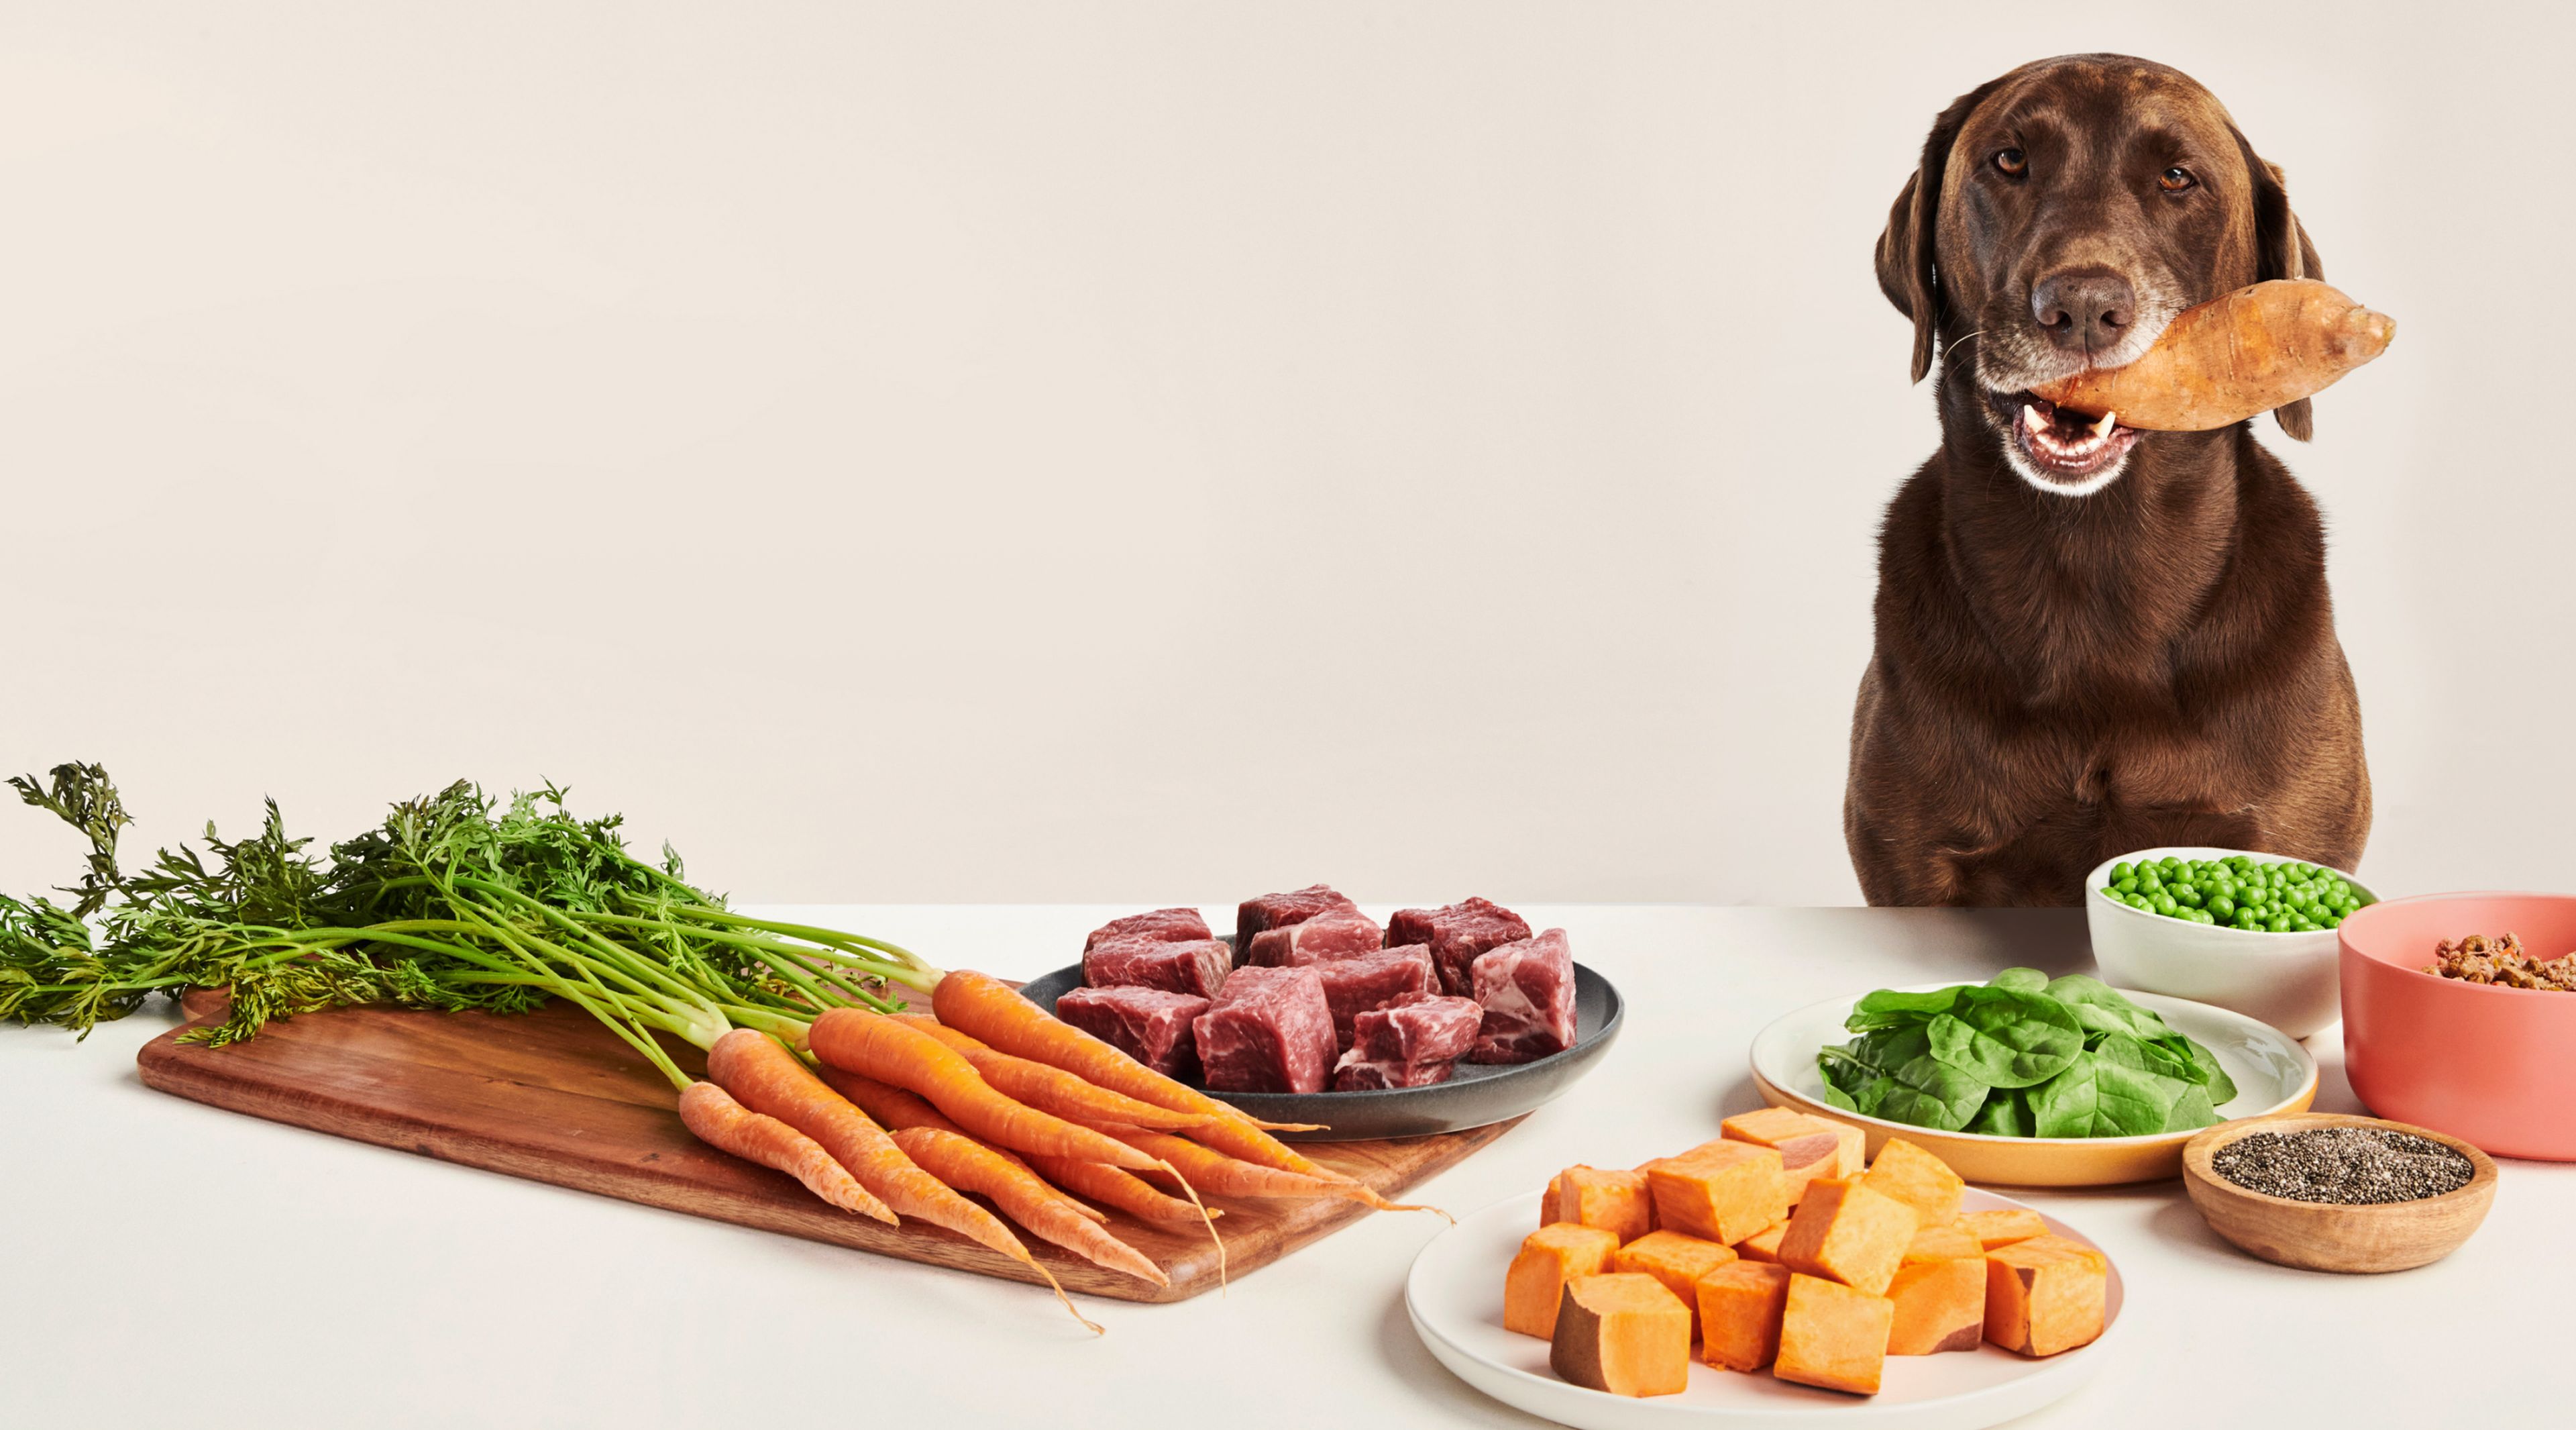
[1752,982,2316,1188]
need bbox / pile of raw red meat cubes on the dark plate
[1056,884,1574,1092]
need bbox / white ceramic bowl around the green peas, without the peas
[2084,845,2377,1038]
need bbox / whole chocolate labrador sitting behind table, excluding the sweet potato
[1842,54,2370,905]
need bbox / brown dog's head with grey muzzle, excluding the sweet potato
[1878,54,2321,495]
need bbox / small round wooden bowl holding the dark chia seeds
[2182,1113,2496,1270]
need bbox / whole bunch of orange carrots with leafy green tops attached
[0,765,1442,1329]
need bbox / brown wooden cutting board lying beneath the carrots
[137,992,1520,1301]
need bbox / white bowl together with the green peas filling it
[2084,848,2377,1038]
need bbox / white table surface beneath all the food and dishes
[0,902,2576,1430]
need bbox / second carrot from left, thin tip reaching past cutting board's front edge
[706,1028,1100,1332]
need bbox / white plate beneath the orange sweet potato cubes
[1404,1188,2123,1430]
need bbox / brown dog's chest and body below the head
[1847,401,2367,902]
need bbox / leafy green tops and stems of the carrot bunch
[0,765,941,1066]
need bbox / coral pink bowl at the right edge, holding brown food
[2337,894,2576,1162]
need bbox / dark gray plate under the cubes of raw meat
[1020,964,1625,1141]
